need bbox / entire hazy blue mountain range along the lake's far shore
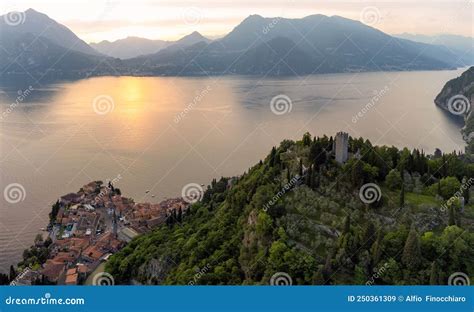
[0,9,472,79]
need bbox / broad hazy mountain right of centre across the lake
[132,15,457,75]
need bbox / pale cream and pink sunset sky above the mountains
[0,0,474,42]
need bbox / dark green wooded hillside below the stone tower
[106,134,474,285]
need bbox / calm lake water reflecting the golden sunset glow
[0,69,464,271]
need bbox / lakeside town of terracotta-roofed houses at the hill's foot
[10,181,189,285]
